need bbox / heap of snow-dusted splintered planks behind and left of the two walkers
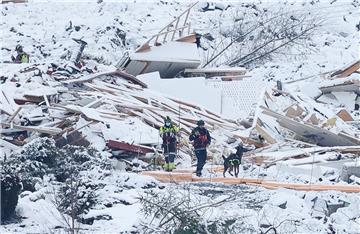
[1,64,250,160]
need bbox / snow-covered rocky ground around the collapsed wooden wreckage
[0,0,360,233]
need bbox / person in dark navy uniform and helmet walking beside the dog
[189,120,211,177]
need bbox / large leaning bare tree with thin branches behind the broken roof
[203,7,323,67]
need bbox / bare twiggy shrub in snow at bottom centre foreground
[138,186,235,233]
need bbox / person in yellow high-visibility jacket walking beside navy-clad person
[160,116,179,171]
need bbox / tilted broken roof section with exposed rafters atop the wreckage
[117,3,201,78]
